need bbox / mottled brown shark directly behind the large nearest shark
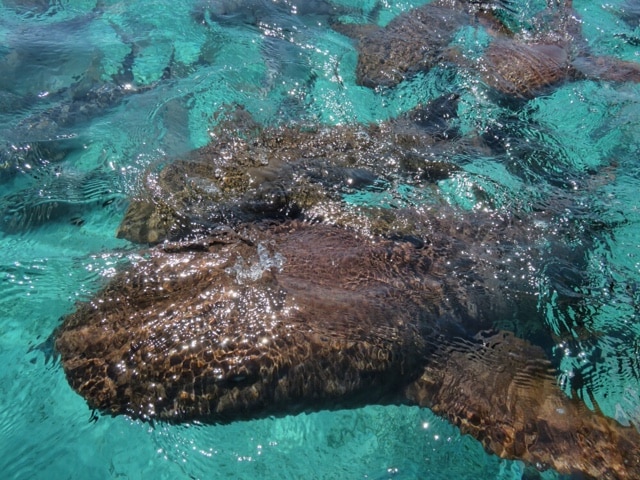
[118,100,464,243]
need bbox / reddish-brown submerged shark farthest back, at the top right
[334,0,640,98]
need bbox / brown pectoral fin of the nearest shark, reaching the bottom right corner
[406,333,640,479]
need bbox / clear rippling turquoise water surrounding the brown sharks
[0,0,640,480]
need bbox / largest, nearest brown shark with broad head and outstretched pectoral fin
[55,216,640,479]
